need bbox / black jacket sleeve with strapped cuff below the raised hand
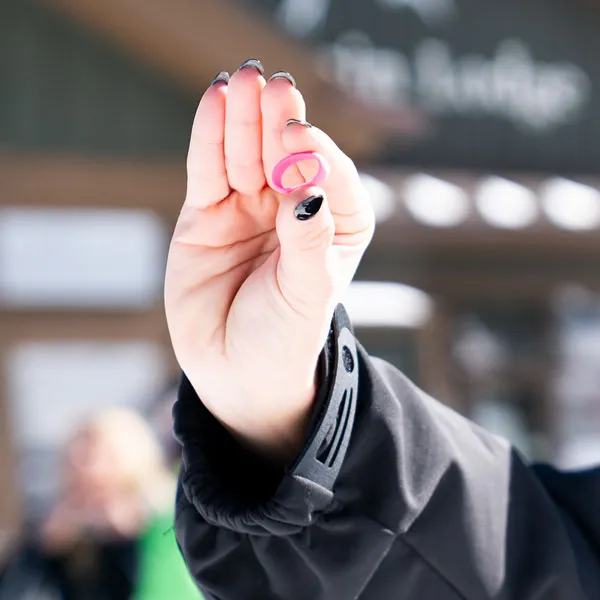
[174,307,600,600]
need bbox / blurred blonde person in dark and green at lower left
[0,408,201,600]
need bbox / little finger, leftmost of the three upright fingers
[185,71,229,208]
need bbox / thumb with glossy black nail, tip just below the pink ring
[276,186,335,315]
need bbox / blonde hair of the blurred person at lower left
[75,407,175,510]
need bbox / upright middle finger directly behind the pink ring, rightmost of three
[261,71,306,187]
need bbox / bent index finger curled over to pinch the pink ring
[282,123,372,217]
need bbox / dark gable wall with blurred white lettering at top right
[241,0,600,172]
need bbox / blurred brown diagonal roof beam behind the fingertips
[38,0,421,159]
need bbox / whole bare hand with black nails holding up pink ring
[165,61,374,459]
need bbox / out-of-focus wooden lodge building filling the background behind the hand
[0,0,600,592]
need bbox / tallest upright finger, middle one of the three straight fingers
[225,59,265,195]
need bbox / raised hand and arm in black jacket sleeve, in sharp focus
[165,60,600,600]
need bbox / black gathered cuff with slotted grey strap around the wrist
[173,305,358,535]
